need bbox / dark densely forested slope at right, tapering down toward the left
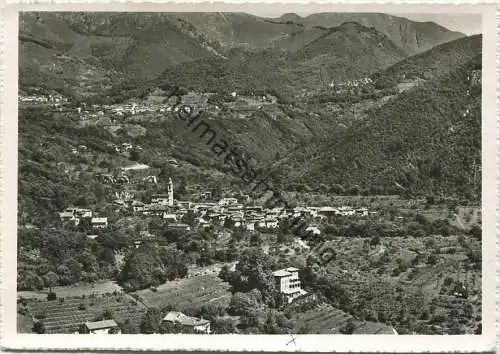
[283,55,481,198]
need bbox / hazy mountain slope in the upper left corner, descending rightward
[19,12,220,93]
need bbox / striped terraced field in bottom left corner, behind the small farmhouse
[27,294,146,333]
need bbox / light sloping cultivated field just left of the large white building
[137,275,231,311]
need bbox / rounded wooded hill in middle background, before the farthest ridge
[159,23,406,96]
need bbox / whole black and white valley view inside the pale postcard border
[4,2,496,350]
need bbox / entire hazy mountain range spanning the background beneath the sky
[19,12,460,97]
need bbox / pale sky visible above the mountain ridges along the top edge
[244,10,482,35]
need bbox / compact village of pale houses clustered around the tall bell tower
[59,176,374,241]
